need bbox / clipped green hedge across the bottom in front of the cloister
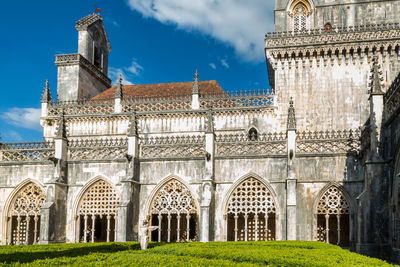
[0,241,391,267]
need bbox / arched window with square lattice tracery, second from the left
[77,180,119,242]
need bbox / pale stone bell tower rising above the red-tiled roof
[56,13,111,101]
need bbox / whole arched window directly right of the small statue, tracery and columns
[150,179,198,242]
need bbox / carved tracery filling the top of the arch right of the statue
[151,179,197,214]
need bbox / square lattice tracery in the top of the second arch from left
[78,180,120,215]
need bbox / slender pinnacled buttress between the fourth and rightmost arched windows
[286,99,297,240]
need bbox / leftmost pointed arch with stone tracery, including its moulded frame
[3,178,46,245]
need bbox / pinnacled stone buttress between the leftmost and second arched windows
[39,115,68,244]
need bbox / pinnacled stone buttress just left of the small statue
[116,113,140,242]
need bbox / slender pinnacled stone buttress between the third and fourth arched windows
[200,110,215,242]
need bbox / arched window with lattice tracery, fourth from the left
[227,178,275,241]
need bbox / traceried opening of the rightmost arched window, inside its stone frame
[317,186,350,247]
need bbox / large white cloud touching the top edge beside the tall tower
[128,0,274,61]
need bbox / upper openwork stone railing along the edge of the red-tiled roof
[48,90,275,116]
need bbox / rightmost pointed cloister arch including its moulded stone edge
[313,182,354,247]
